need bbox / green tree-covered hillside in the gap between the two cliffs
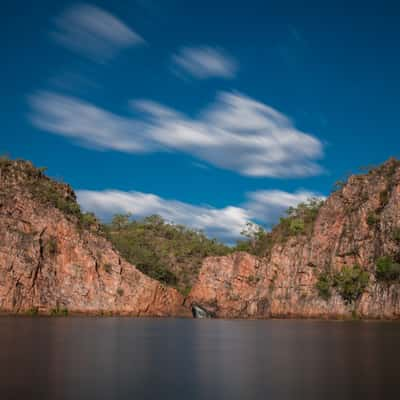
[103,214,232,292]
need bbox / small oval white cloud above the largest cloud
[172,46,238,79]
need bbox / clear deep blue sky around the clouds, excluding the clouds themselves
[0,0,400,211]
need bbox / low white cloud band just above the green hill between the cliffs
[77,190,324,243]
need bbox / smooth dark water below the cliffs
[0,317,400,400]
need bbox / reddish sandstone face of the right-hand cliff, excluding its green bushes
[186,160,400,319]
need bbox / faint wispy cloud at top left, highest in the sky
[52,3,144,62]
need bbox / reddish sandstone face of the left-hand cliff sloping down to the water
[0,162,189,316]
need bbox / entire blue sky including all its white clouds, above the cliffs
[0,0,400,241]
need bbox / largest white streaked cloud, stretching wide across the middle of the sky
[30,92,323,177]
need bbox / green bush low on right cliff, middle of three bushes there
[333,265,369,304]
